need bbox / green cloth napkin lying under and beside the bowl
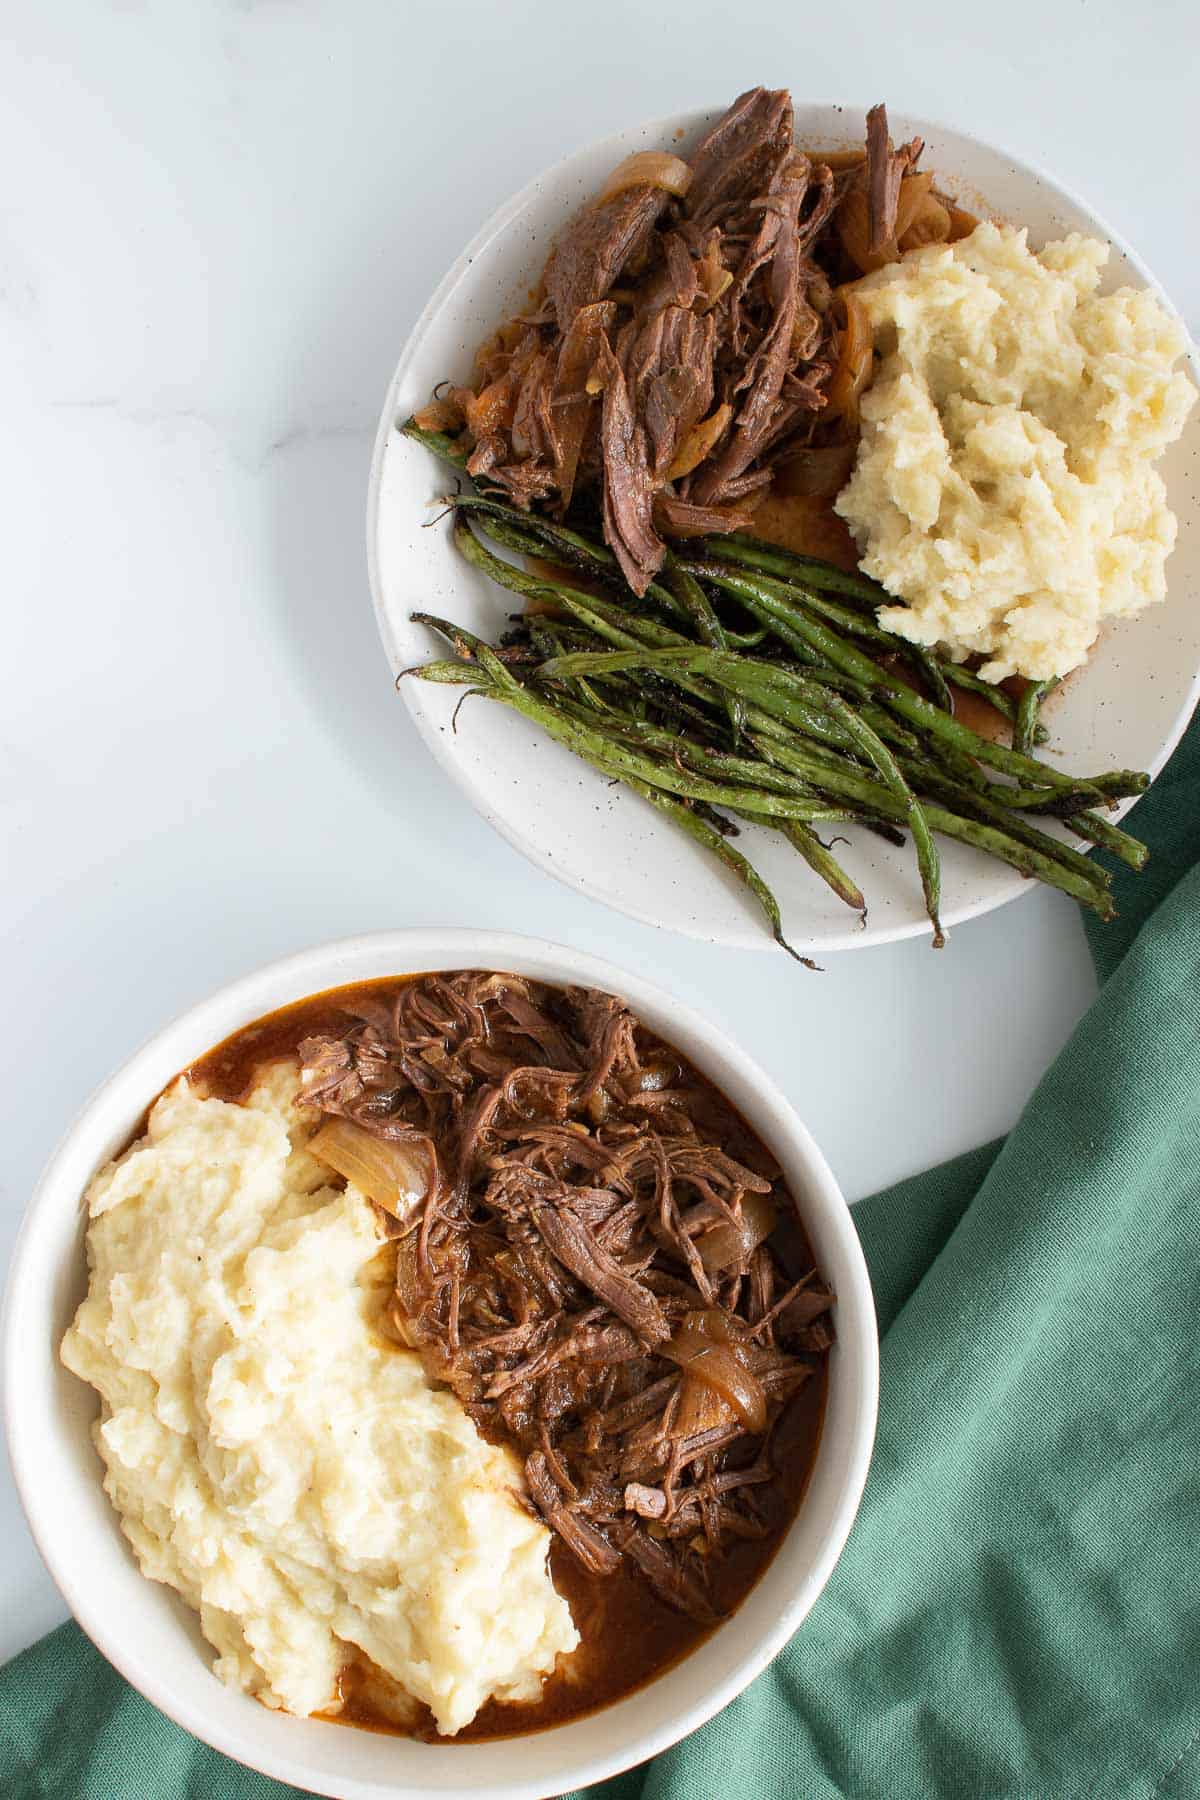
[0,722,1200,1800]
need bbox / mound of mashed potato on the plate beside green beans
[837,225,1196,680]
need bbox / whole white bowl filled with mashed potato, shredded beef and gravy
[4,931,878,1800]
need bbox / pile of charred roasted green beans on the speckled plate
[408,419,1148,954]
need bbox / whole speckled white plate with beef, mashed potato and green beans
[369,88,1200,958]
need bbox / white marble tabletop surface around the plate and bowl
[0,0,1200,1656]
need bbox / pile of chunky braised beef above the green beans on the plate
[422,88,921,594]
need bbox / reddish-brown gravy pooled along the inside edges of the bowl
[185,976,828,1744]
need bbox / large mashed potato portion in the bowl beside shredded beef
[63,1066,579,1732]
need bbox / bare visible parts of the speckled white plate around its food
[367,103,1200,950]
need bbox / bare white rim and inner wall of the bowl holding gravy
[4,929,878,1800]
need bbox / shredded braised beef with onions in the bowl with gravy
[300,970,833,1624]
